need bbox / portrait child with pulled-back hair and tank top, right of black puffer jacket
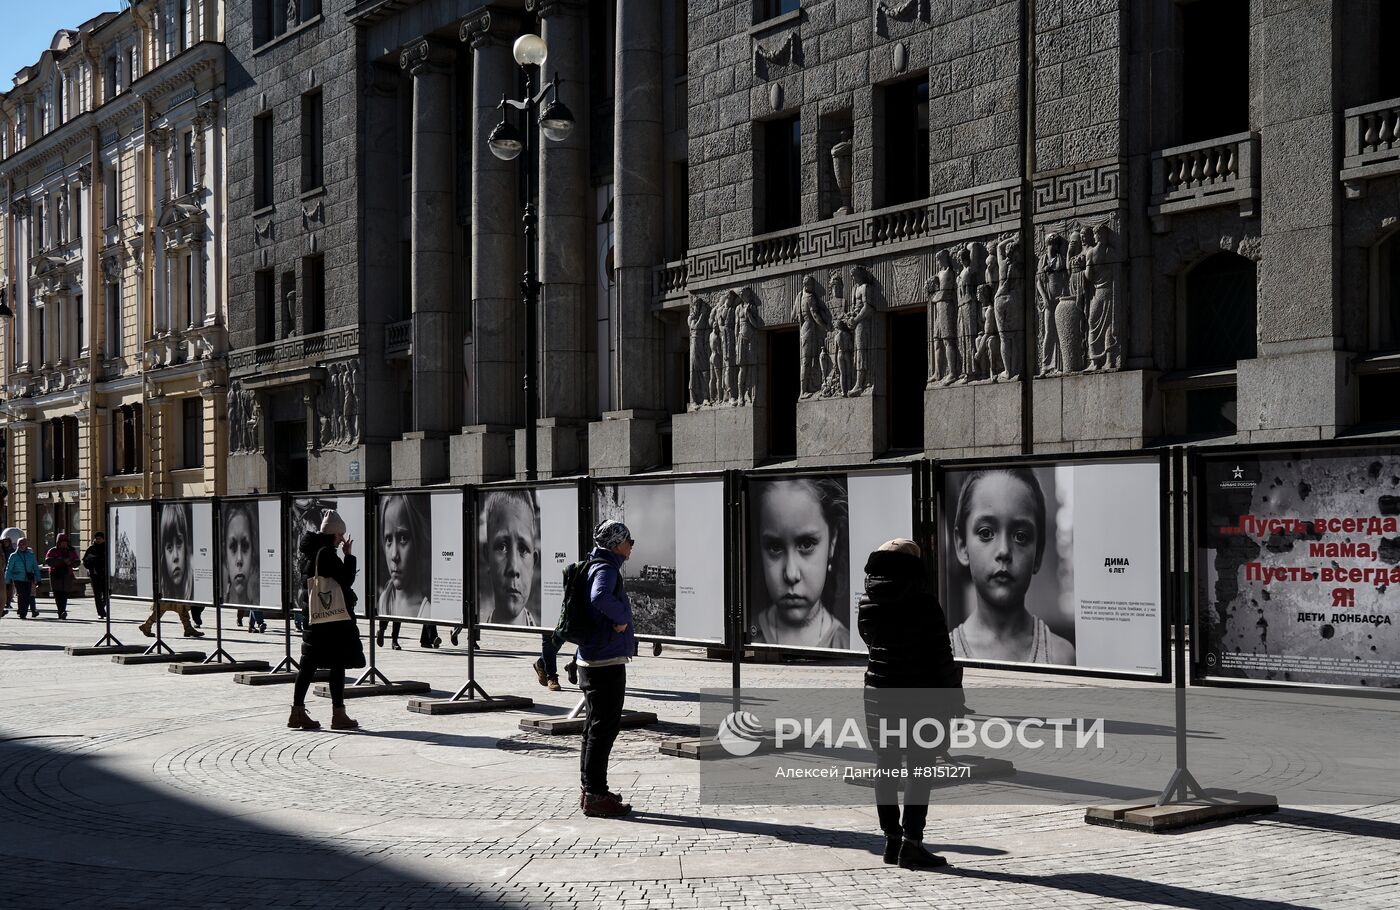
[946,468,1075,666]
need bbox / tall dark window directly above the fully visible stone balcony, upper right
[1180,0,1249,143]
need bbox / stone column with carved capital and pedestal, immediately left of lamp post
[452,8,525,483]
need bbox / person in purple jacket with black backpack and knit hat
[577,521,637,818]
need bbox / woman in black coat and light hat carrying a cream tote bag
[287,511,364,729]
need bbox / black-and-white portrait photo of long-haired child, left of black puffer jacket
[749,476,851,650]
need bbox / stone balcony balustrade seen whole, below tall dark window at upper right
[1148,133,1259,232]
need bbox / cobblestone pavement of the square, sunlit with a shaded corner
[0,602,1400,910]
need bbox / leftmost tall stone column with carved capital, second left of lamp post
[399,38,461,434]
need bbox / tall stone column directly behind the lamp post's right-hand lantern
[538,0,591,477]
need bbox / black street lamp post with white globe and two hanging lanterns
[487,35,574,480]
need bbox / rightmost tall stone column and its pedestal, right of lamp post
[589,0,665,470]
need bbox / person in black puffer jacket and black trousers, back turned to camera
[857,538,962,869]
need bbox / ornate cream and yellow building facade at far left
[0,0,227,545]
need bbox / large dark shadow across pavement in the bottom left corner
[0,739,519,910]
